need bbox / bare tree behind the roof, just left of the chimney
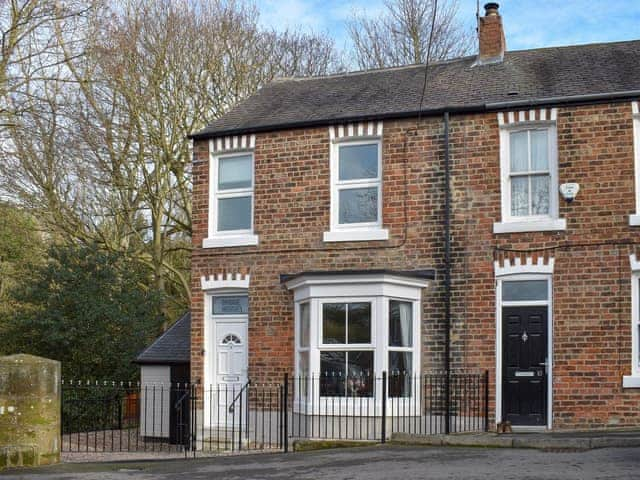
[348,0,473,69]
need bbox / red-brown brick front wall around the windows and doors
[192,103,640,428]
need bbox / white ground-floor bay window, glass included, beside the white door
[285,272,431,412]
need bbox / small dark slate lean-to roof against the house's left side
[135,312,191,365]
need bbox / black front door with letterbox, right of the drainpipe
[502,306,548,426]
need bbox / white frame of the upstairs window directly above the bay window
[323,138,389,242]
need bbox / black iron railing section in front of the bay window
[287,372,489,442]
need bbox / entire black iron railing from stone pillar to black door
[62,372,488,456]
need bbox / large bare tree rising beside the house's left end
[0,0,340,316]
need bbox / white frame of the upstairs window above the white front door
[202,149,258,248]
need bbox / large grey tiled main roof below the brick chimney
[194,40,640,138]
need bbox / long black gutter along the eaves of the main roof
[187,90,640,140]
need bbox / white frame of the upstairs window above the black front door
[493,120,567,233]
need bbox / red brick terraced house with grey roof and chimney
[191,4,640,429]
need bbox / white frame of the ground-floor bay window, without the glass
[287,274,429,415]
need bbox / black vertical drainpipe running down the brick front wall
[444,112,451,433]
